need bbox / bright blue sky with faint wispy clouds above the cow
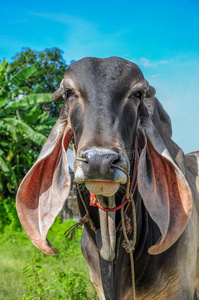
[0,0,199,152]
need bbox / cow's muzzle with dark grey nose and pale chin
[75,148,128,197]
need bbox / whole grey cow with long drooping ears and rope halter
[17,57,199,300]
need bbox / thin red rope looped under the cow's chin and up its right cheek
[89,137,138,211]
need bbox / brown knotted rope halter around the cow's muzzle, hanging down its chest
[65,141,139,300]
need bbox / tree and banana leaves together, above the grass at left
[0,48,67,198]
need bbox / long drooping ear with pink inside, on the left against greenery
[16,103,72,254]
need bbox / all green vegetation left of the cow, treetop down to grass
[0,48,96,300]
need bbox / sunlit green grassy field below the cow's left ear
[0,219,97,300]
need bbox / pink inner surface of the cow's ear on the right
[138,141,192,254]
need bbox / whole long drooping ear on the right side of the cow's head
[138,99,192,255]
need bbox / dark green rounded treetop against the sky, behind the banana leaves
[10,48,67,95]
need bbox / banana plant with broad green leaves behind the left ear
[0,59,55,199]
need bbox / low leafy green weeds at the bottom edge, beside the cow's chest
[21,259,97,300]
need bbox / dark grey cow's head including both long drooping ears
[17,57,191,260]
